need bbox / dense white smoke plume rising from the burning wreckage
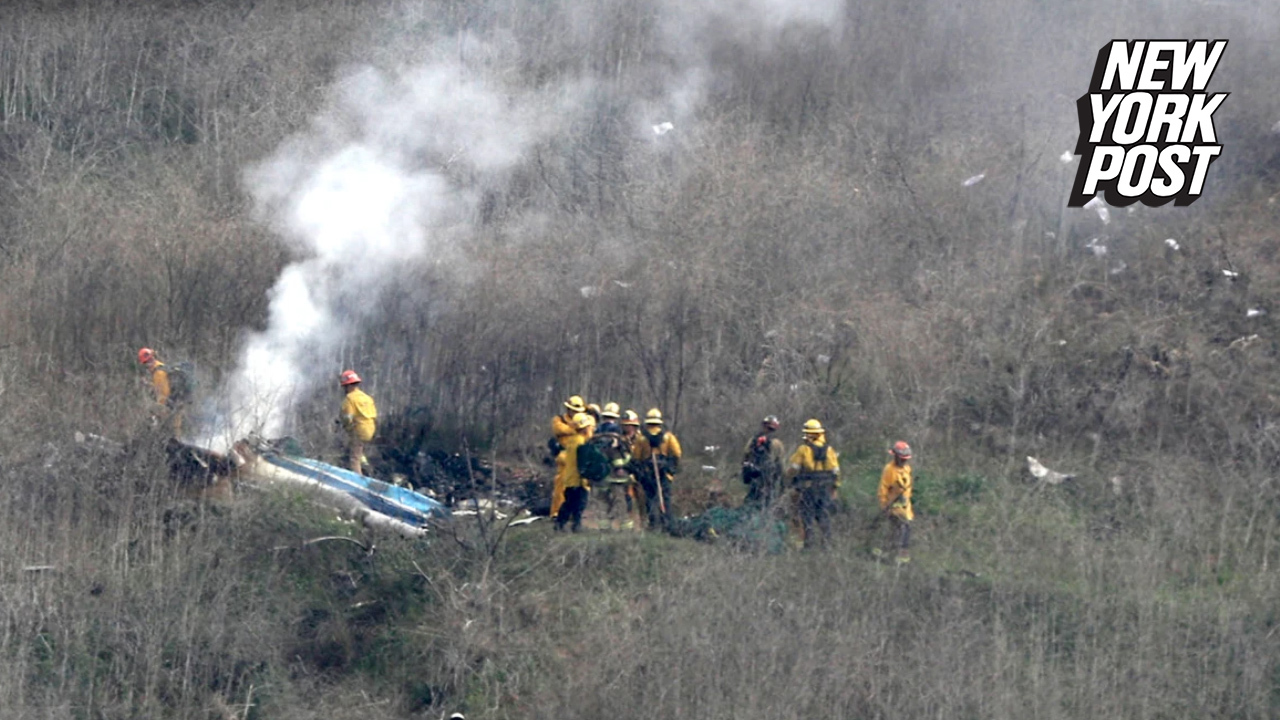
[201,51,556,448]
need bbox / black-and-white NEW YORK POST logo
[1068,40,1229,208]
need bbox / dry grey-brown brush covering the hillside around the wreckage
[0,0,1280,720]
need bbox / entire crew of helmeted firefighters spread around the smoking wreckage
[138,347,915,562]
